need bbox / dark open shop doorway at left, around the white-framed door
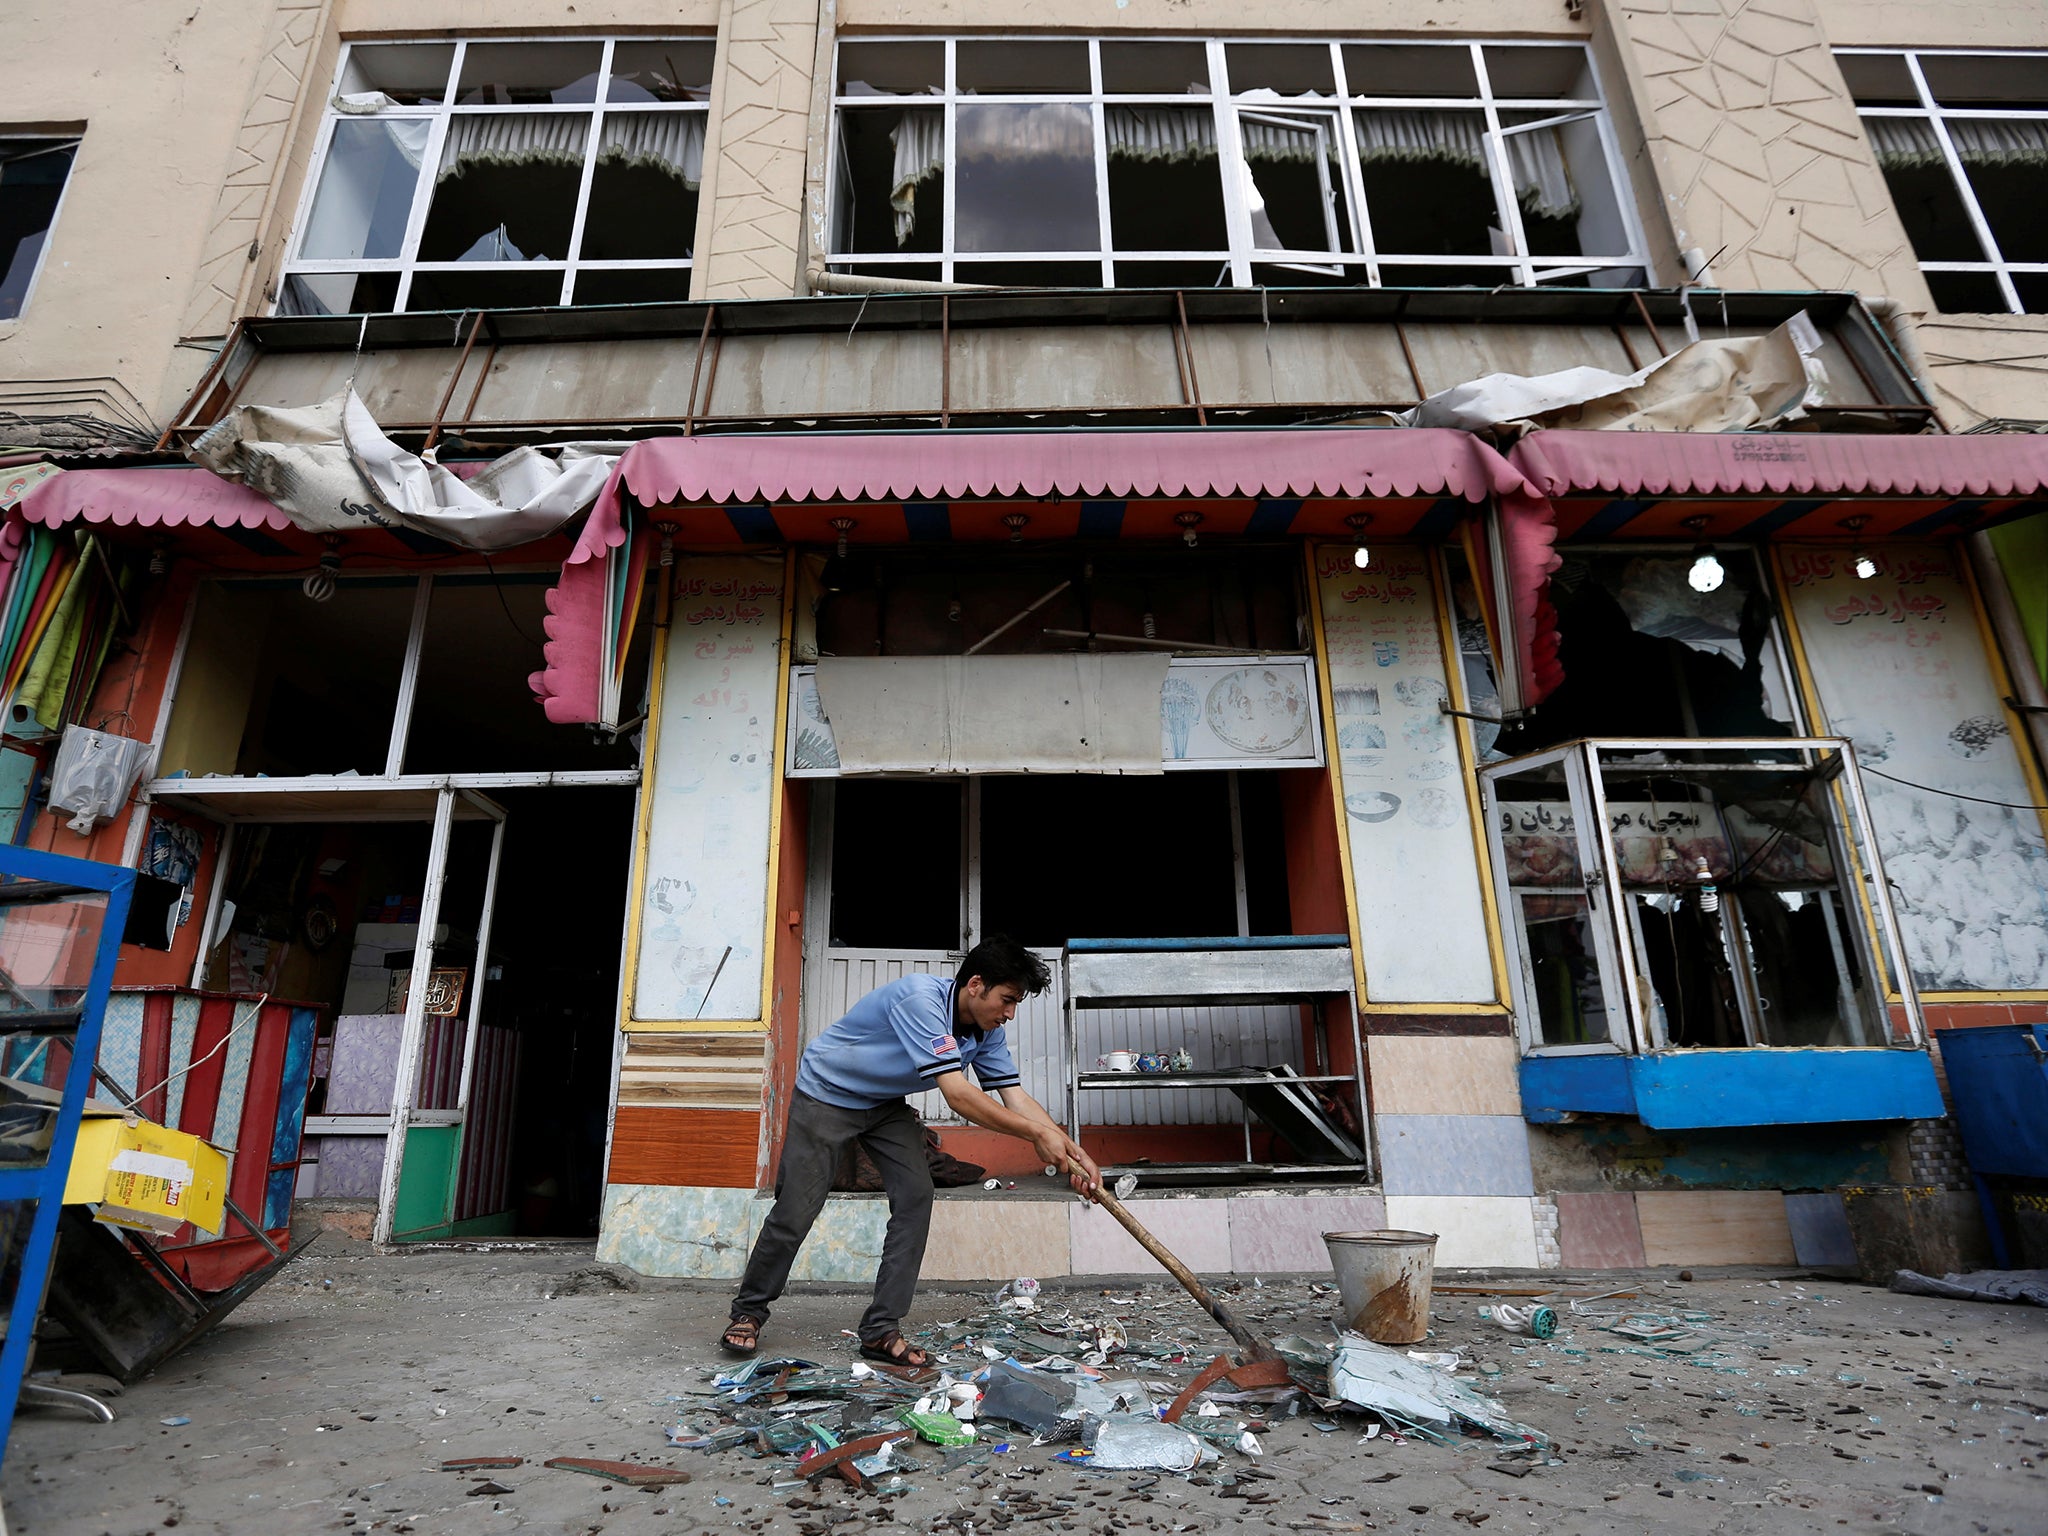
[205,786,635,1237]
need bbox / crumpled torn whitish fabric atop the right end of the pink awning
[1395,309,1827,432]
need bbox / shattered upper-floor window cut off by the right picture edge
[1837,51,2048,315]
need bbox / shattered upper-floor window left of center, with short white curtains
[276,37,713,315]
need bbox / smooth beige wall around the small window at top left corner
[0,0,276,436]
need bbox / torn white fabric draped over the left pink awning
[188,389,627,555]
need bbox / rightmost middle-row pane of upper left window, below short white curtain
[578,113,705,259]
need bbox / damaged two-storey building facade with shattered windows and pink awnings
[0,0,2048,1280]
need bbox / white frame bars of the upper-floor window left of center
[272,33,711,313]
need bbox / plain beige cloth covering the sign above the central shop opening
[817,653,1169,774]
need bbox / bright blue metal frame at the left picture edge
[0,846,135,1458]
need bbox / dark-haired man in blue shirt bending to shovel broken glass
[721,938,1102,1370]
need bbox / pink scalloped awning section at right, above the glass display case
[1507,430,2048,498]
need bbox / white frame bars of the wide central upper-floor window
[825,33,1651,289]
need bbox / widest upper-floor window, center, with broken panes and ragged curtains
[827,39,1642,287]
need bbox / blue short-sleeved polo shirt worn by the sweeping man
[797,975,1022,1110]
